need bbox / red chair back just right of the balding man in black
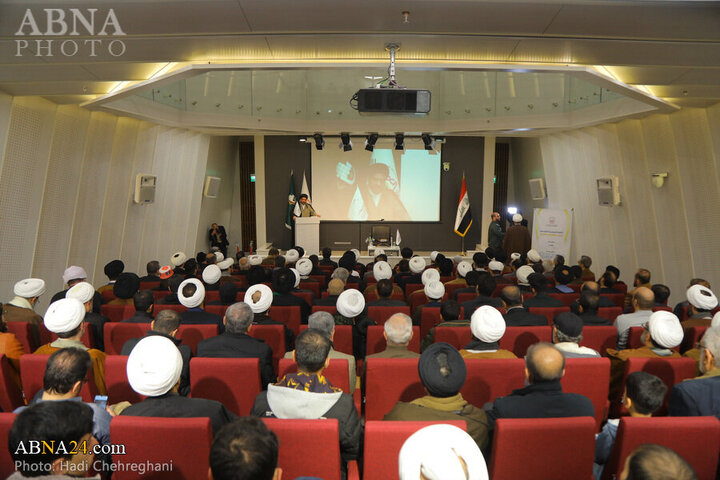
[560,358,610,431]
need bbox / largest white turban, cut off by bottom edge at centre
[398,424,489,480]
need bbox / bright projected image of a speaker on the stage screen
[312,147,440,222]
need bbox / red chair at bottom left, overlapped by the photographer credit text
[110,415,212,480]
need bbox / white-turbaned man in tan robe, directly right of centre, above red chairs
[460,305,517,358]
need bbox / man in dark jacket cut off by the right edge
[669,328,720,419]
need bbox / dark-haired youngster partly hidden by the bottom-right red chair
[593,372,667,480]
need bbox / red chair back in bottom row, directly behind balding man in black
[490,417,595,480]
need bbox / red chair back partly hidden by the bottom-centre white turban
[363,420,467,479]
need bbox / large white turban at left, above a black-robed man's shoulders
[126,335,182,397]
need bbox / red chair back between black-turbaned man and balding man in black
[458,358,525,408]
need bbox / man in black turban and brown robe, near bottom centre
[383,343,488,449]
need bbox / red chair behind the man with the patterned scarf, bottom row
[262,418,360,480]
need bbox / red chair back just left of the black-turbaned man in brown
[365,358,426,420]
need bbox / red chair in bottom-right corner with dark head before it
[602,417,720,480]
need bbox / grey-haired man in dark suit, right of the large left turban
[198,302,275,388]
